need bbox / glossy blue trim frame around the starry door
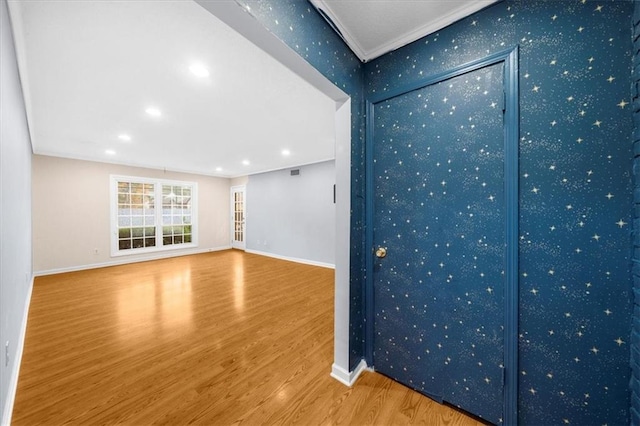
[364,46,520,425]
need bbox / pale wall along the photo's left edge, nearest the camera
[0,0,33,425]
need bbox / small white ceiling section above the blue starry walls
[309,0,501,61]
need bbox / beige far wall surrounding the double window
[33,155,230,275]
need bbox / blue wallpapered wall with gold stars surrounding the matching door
[234,0,640,425]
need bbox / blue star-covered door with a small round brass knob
[373,64,507,423]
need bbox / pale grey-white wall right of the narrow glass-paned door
[245,161,336,266]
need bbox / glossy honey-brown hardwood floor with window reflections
[13,250,481,425]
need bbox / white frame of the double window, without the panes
[109,175,198,257]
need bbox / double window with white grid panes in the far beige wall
[111,176,197,255]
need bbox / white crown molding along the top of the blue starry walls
[309,0,501,62]
